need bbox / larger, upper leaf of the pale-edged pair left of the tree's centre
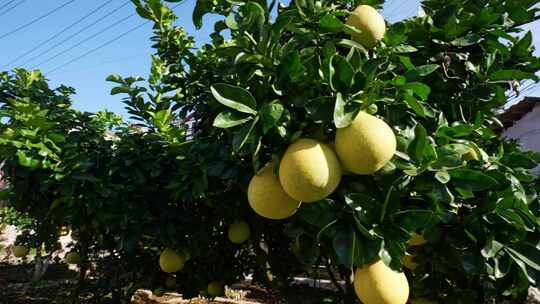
[210,83,257,114]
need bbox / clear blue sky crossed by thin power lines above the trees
[6,0,540,119]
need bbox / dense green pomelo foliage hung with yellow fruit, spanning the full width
[0,0,540,304]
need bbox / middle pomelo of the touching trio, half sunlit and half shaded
[279,139,341,203]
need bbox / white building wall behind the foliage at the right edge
[502,103,540,173]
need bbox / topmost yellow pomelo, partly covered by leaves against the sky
[347,5,386,49]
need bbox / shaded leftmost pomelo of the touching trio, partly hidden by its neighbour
[248,164,300,220]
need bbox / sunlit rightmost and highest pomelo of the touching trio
[336,112,396,175]
